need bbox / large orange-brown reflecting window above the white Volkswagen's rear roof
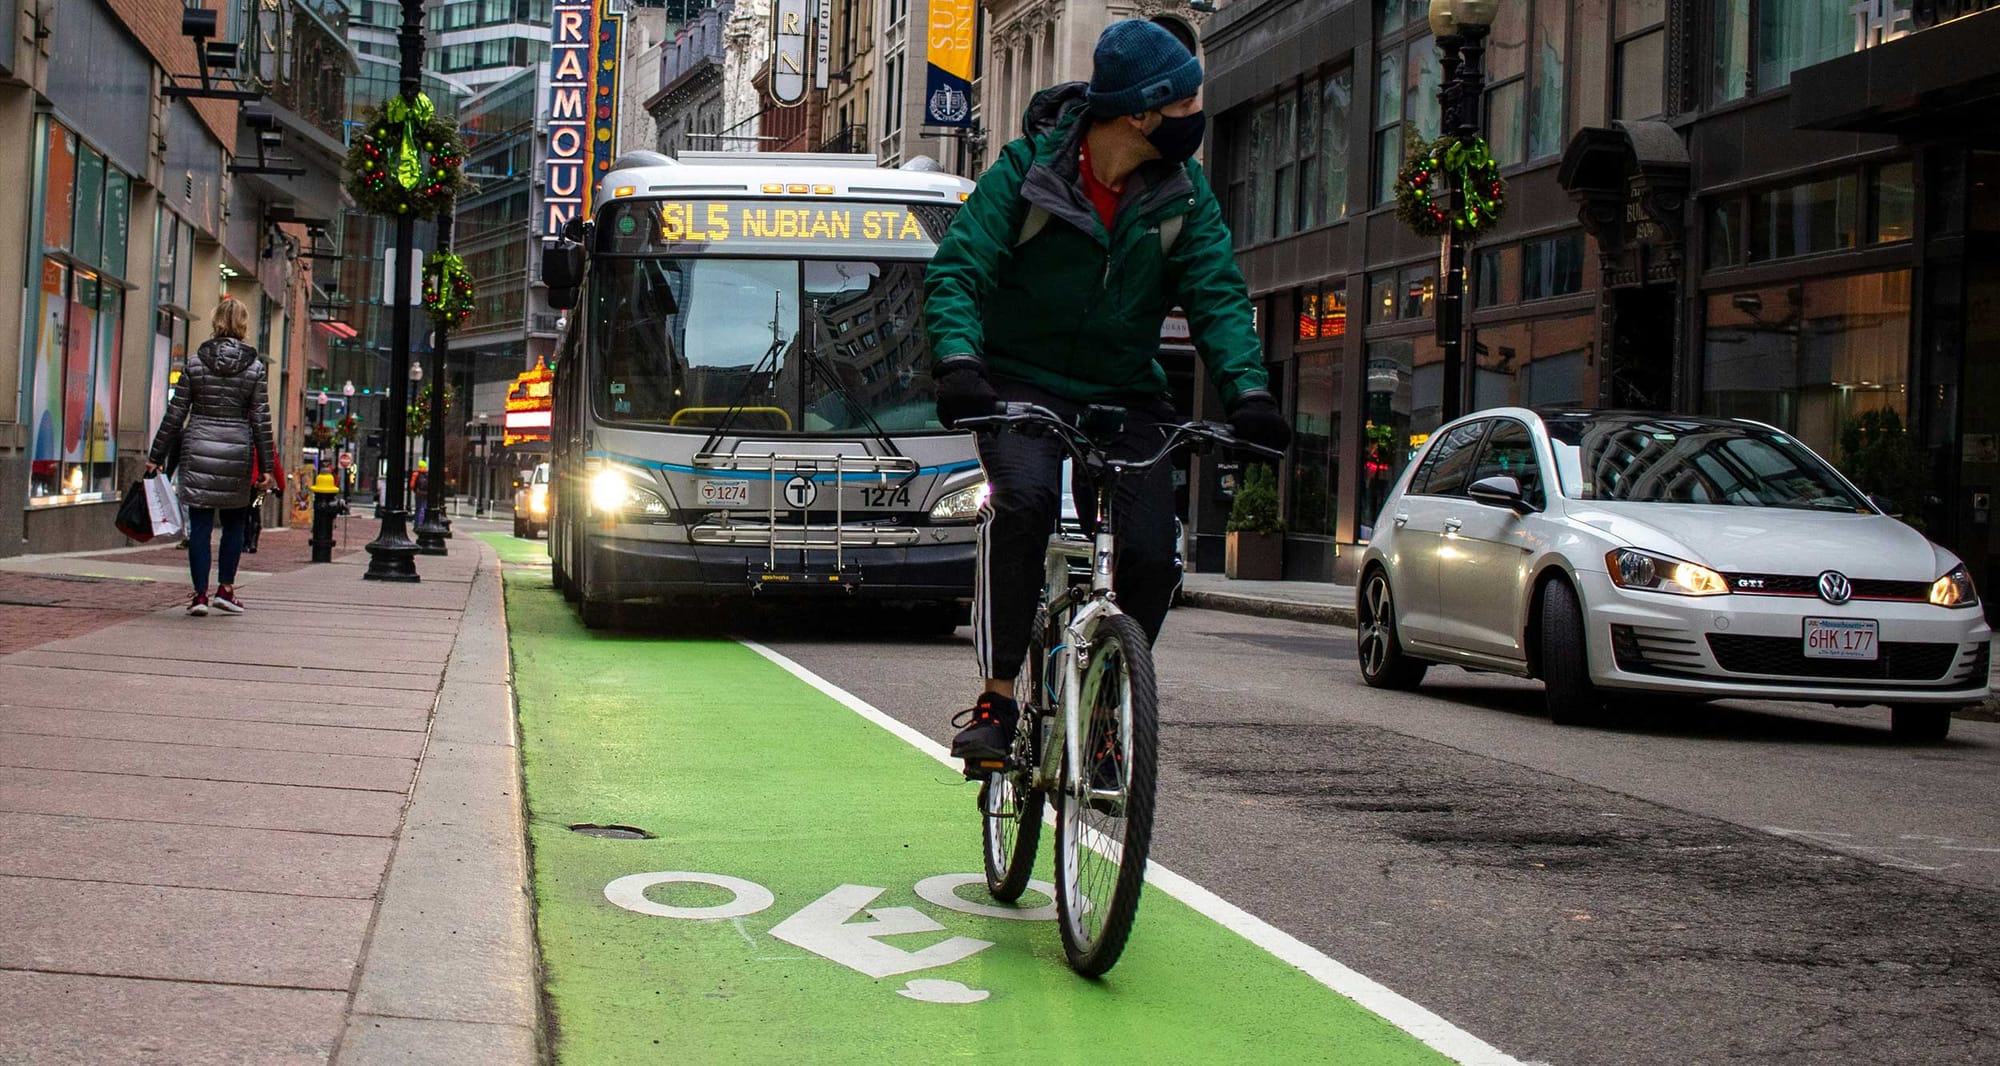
[1702,270,1910,456]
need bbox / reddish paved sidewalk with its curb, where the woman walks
[0,534,538,1066]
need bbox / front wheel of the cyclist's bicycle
[1056,614,1160,978]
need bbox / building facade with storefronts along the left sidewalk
[0,0,354,556]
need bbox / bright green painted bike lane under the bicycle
[482,534,1512,1066]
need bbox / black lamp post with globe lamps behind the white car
[1430,0,1500,422]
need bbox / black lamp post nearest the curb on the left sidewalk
[362,0,424,582]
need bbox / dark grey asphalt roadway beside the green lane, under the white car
[752,610,2000,1066]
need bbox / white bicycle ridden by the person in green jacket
[958,404,1282,978]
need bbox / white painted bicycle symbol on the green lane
[604,870,1056,1004]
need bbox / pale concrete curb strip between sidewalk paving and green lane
[334,538,546,1066]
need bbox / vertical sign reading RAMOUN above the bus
[542,0,624,236]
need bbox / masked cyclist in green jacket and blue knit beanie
[924,18,1292,778]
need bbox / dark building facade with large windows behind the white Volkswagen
[1194,0,2000,580]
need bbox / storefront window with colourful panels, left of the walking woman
[28,118,132,502]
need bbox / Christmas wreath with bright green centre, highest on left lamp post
[348,92,466,216]
